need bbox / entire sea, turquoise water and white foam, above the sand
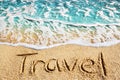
[0,0,120,49]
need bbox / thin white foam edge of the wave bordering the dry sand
[0,39,120,49]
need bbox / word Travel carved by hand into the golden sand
[17,53,107,76]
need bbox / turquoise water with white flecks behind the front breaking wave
[0,0,120,24]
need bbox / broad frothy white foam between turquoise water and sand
[1,18,120,49]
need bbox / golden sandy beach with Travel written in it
[0,44,120,80]
